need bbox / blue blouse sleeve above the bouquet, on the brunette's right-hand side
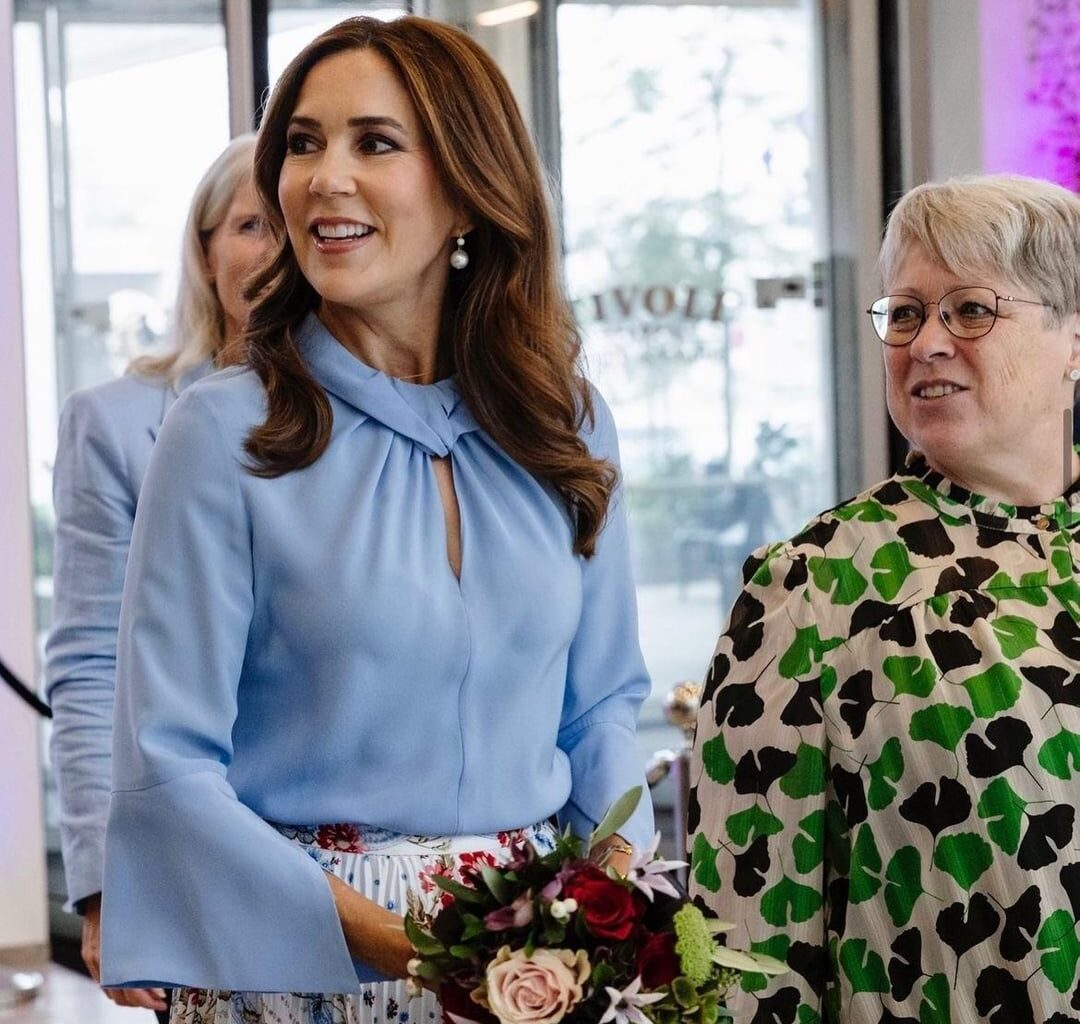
[558,391,653,849]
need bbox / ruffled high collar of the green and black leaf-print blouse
[901,452,1080,534]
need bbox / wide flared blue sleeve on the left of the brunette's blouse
[102,382,381,993]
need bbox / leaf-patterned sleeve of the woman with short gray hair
[688,544,829,1021]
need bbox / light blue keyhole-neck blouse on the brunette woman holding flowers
[102,315,652,992]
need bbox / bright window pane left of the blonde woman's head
[65,24,229,278]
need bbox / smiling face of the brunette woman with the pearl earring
[278,49,464,328]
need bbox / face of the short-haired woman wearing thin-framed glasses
[882,243,1080,496]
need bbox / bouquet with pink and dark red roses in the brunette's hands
[405,786,785,1024]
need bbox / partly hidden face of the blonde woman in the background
[206,180,273,343]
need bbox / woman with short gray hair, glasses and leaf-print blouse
[690,176,1080,1024]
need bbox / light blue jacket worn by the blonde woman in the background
[45,361,213,910]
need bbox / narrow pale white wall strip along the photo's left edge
[0,0,49,953]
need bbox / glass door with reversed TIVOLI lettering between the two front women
[557,0,834,756]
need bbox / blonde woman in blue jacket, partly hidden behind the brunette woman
[46,135,270,1011]
